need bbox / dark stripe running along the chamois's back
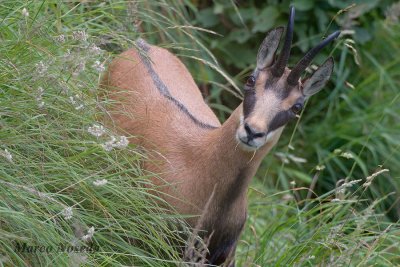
[136,39,218,129]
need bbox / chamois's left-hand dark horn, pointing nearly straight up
[272,6,294,77]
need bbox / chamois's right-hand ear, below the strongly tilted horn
[303,57,334,98]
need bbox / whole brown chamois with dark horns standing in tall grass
[102,7,340,266]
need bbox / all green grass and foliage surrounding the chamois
[0,0,400,266]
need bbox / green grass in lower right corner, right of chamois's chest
[238,178,400,266]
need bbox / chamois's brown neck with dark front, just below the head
[198,105,282,206]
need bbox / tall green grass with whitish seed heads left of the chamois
[0,1,191,266]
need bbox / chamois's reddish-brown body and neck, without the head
[103,43,279,264]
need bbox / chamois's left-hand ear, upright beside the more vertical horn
[257,27,283,70]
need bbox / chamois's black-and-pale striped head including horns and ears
[236,7,340,150]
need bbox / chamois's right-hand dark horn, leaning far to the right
[287,31,340,85]
